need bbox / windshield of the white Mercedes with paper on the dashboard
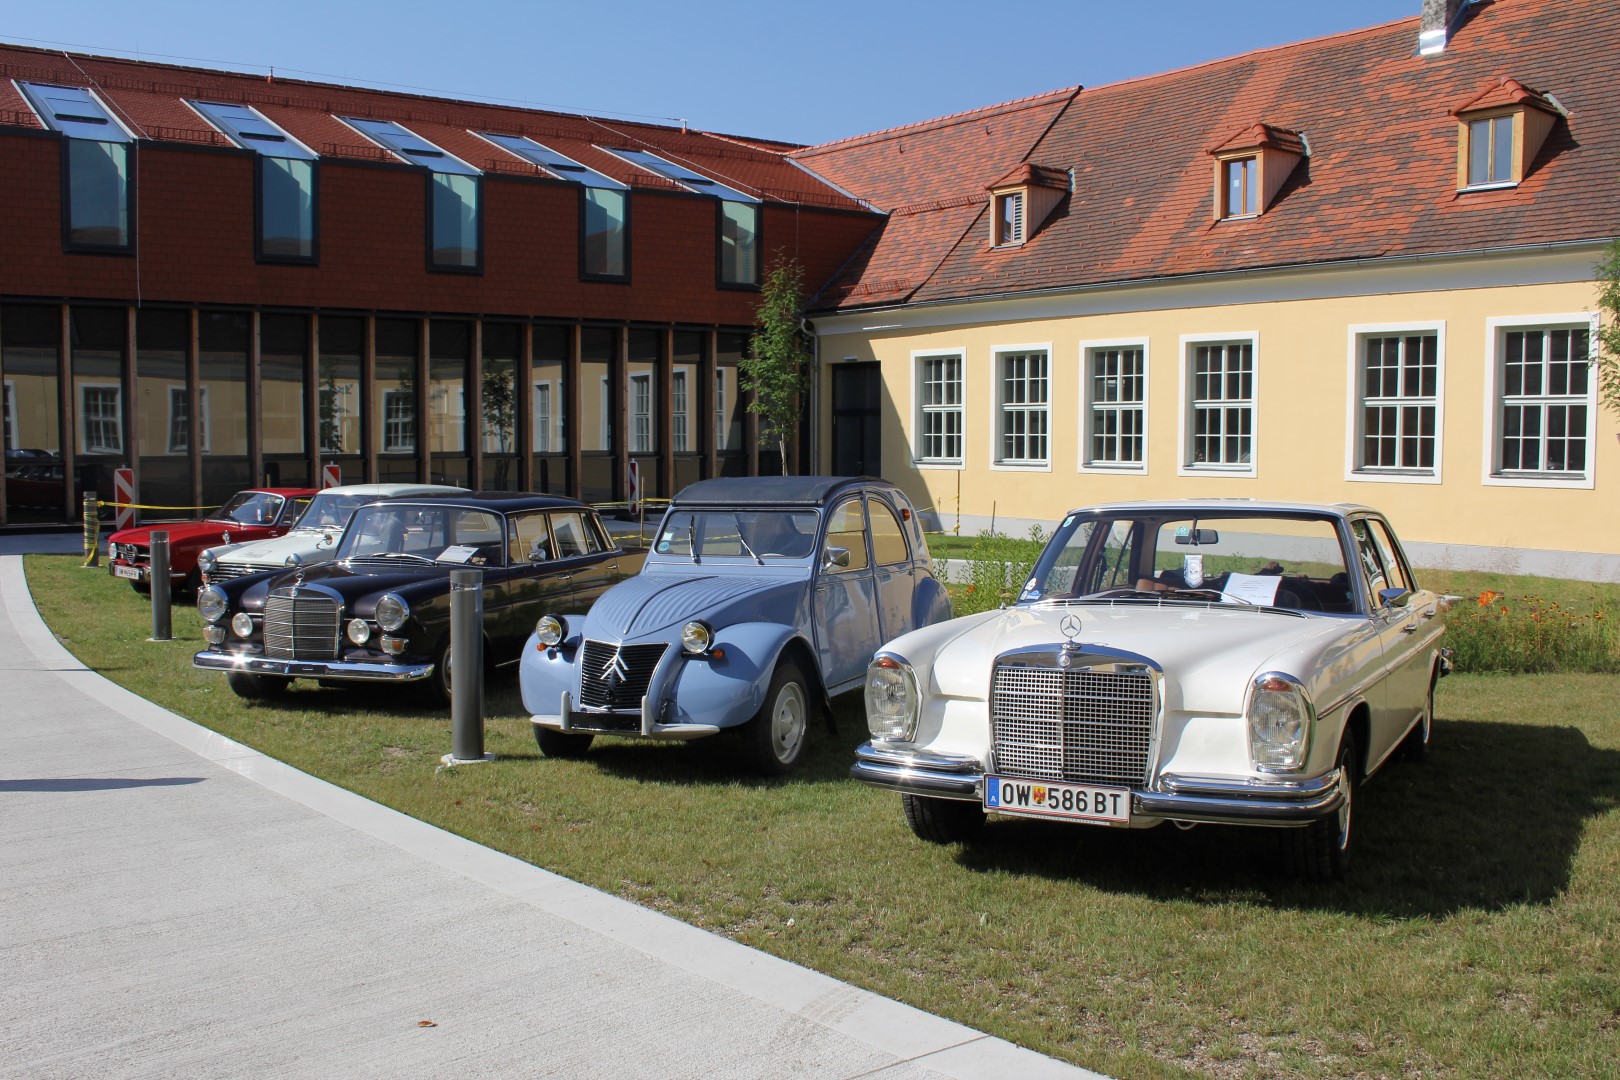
[1019,510,1356,612]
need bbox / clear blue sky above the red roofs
[9,0,1422,142]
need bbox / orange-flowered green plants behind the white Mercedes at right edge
[1445,589,1620,675]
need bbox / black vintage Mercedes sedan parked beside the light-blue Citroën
[193,492,642,701]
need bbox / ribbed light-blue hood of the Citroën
[585,572,807,640]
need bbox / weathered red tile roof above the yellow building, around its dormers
[794,0,1620,309]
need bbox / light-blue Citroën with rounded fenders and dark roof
[518,476,951,772]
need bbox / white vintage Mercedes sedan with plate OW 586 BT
[852,500,1450,881]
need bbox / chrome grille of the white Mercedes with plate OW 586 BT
[990,664,1157,787]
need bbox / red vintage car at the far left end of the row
[107,487,319,593]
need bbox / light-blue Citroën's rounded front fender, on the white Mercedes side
[659,622,803,727]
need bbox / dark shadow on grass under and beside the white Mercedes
[957,721,1620,918]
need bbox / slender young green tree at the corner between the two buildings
[737,256,815,476]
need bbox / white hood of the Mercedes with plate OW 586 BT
[933,602,1366,712]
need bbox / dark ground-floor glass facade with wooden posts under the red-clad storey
[0,304,754,523]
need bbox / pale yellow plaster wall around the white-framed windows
[820,282,1620,554]
